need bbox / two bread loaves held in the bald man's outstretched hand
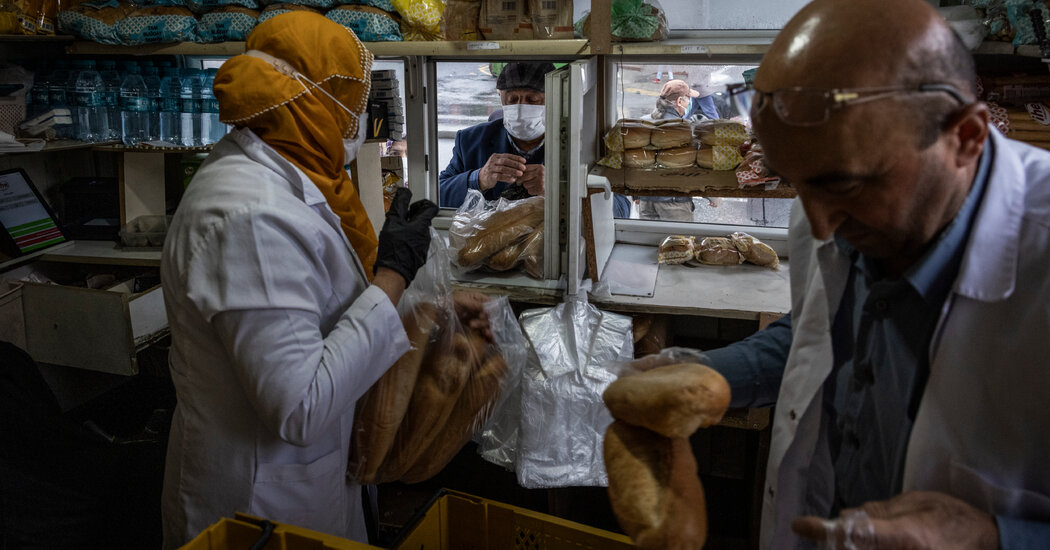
[602,355,730,550]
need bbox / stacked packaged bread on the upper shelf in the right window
[599,119,750,170]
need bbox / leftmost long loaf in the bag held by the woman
[348,303,445,485]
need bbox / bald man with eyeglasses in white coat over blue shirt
[692,0,1050,549]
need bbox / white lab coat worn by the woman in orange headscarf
[161,129,408,548]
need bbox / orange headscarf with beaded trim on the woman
[214,12,378,278]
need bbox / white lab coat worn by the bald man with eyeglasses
[761,131,1050,549]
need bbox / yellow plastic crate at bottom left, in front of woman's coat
[180,512,379,550]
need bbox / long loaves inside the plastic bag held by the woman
[349,303,507,485]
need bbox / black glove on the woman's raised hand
[374,187,438,284]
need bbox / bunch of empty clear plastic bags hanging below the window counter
[516,297,634,488]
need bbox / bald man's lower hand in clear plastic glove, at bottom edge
[792,491,999,550]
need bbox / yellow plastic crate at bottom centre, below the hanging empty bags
[394,489,634,550]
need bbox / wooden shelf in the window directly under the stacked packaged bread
[590,166,795,198]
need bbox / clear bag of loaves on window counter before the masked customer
[448,189,544,278]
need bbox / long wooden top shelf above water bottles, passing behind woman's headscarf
[66,40,590,58]
